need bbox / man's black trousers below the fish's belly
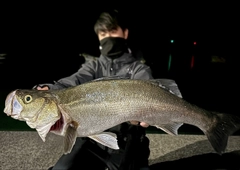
[52,136,149,170]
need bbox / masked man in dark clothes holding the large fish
[35,10,153,170]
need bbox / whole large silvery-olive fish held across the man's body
[4,78,240,154]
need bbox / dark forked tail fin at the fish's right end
[206,113,240,155]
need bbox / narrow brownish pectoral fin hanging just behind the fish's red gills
[64,122,77,154]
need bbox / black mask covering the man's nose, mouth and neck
[100,37,128,58]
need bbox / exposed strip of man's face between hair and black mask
[98,27,128,41]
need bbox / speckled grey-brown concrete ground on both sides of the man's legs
[0,131,240,170]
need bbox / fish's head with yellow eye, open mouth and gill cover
[4,89,61,141]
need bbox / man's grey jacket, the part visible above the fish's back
[40,53,153,89]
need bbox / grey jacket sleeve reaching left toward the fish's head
[38,61,96,90]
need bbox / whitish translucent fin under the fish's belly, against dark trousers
[88,132,119,149]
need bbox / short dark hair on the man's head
[94,10,127,34]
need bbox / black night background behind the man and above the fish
[0,1,239,132]
